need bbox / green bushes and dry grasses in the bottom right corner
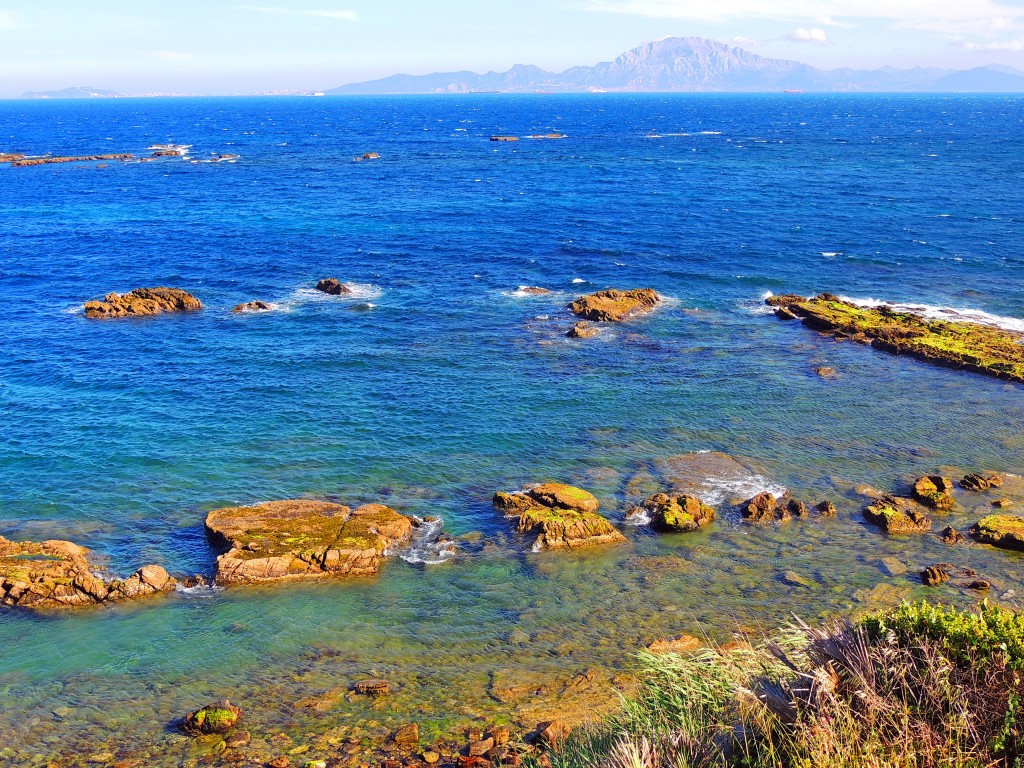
[555,603,1024,768]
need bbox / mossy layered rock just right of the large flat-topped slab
[494,482,626,552]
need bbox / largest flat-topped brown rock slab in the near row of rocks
[206,500,418,585]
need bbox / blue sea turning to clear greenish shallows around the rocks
[0,95,1024,765]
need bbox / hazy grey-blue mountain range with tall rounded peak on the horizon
[326,37,1024,95]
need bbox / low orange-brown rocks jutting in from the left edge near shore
[0,537,175,608]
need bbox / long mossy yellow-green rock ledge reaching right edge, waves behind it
[766,293,1024,382]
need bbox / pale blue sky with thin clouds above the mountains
[0,0,1024,97]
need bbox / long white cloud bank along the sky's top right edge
[583,0,1024,34]
